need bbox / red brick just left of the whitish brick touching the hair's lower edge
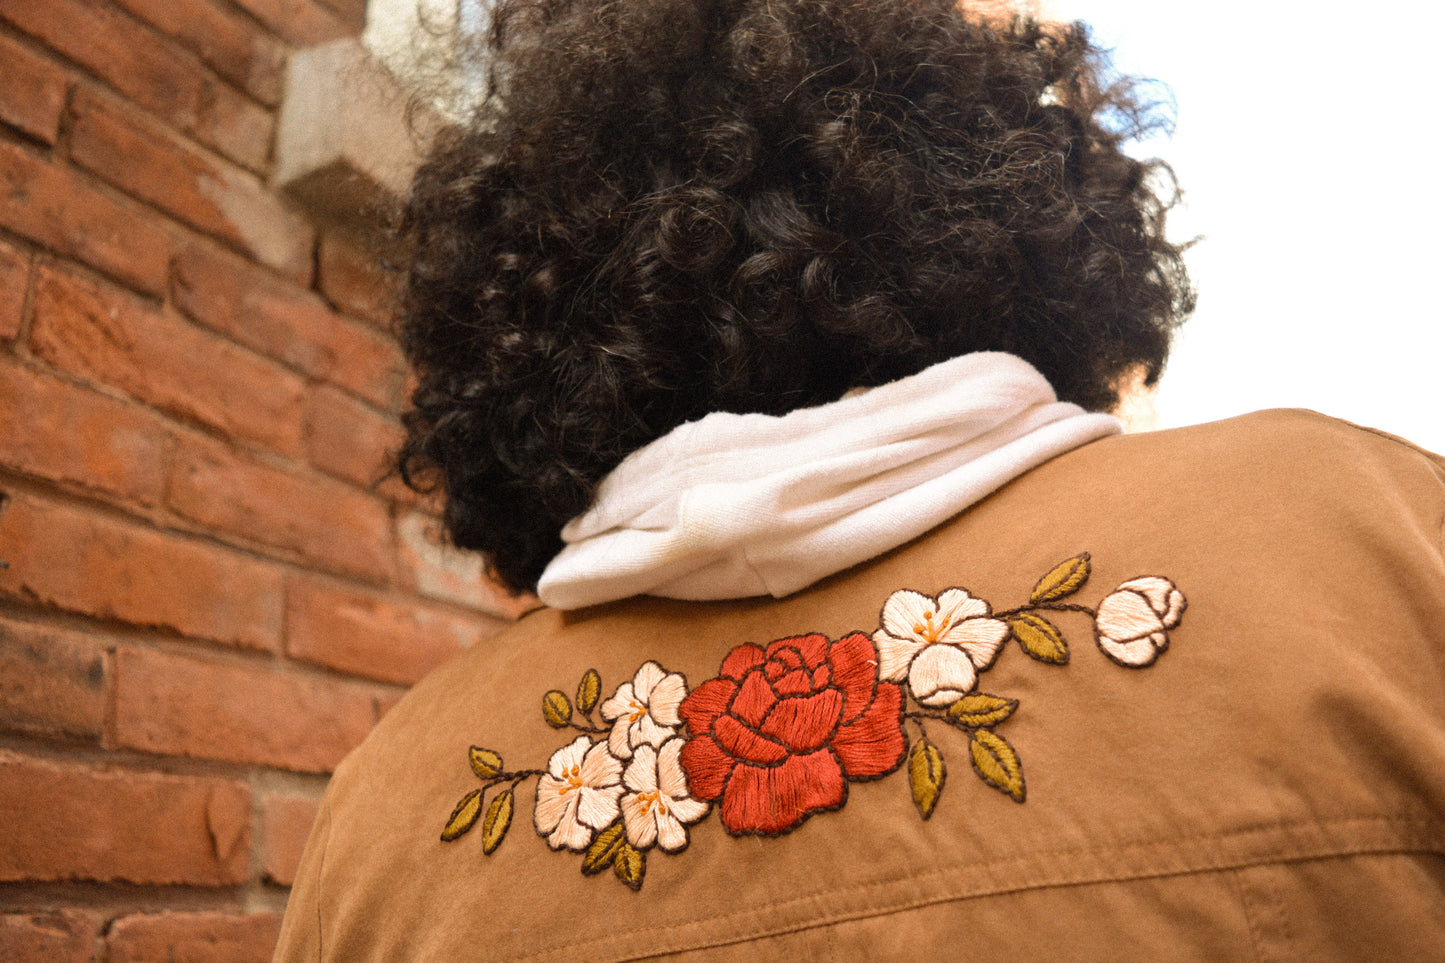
[168,440,392,580]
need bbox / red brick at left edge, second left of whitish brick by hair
[0,352,169,505]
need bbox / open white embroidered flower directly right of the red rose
[873,589,1009,707]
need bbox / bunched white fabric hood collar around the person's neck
[538,351,1123,609]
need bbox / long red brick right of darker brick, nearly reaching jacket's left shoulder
[114,649,376,772]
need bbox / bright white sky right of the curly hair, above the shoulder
[1051,0,1445,451]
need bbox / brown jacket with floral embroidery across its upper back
[277,412,1445,962]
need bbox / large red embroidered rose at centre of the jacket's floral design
[678,632,906,834]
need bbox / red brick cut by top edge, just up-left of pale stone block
[117,0,286,107]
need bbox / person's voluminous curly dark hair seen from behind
[399,0,1192,590]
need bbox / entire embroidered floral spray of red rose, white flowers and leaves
[441,552,1185,891]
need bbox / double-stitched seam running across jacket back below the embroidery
[517,816,1445,960]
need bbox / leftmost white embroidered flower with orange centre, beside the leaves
[532,736,623,850]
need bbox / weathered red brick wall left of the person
[0,0,517,962]
